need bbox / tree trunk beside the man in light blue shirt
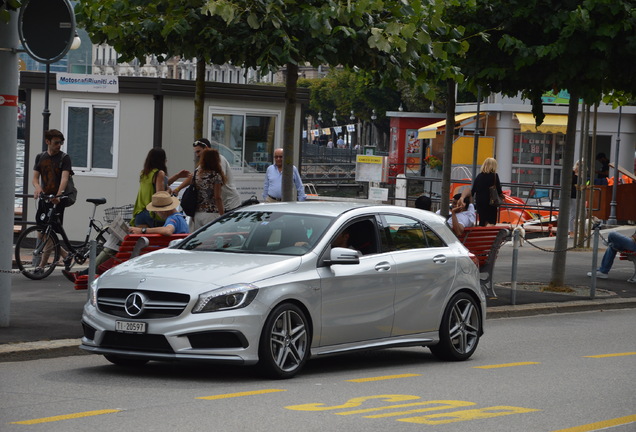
[282,63,298,201]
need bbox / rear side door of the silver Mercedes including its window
[381,214,457,336]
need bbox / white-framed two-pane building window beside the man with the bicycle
[63,100,119,175]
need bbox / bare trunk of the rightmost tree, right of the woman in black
[550,91,579,287]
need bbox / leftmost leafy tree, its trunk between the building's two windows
[75,0,234,139]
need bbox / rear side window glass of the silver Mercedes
[383,215,444,251]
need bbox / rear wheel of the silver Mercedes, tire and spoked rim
[430,293,482,361]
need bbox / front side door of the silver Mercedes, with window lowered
[315,216,396,346]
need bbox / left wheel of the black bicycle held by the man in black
[15,226,60,280]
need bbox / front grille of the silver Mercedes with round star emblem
[97,288,190,319]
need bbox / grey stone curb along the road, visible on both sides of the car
[0,298,636,363]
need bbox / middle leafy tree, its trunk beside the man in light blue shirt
[205,0,466,200]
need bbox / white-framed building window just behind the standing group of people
[209,108,280,172]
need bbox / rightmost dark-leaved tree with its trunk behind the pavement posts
[449,0,636,287]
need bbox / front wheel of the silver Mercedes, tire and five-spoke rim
[258,303,311,379]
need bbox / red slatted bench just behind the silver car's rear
[458,226,510,297]
